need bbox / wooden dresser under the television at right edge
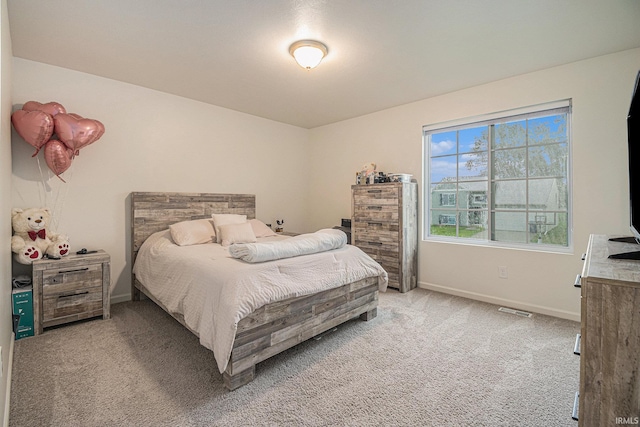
[578,235,640,427]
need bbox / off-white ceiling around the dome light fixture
[8,0,640,128]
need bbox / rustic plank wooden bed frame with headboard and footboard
[131,192,378,390]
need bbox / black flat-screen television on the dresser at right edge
[609,72,640,260]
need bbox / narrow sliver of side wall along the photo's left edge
[0,0,13,425]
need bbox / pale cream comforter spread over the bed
[133,230,387,373]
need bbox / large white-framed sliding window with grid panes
[423,100,571,250]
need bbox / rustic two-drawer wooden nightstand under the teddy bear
[32,250,111,335]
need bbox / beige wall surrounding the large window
[309,49,640,319]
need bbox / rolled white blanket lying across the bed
[229,228,347,262]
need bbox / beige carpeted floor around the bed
[10,289,580,427]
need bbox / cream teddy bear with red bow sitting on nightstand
[11,208,70,264]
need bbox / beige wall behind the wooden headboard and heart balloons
[11,58,309,302]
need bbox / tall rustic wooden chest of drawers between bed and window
[351,182,418,292]
